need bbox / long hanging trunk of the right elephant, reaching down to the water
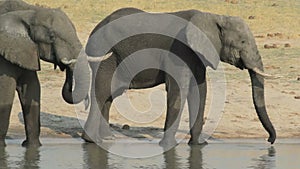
[248,66,276,144]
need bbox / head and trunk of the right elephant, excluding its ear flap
[187,13,276,143]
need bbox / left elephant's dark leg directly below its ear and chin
[17,71,41,147]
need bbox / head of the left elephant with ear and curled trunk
[0,8,88,103]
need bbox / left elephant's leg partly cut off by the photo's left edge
[0,74,16,146]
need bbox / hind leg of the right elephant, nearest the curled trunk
[82,61,114,143]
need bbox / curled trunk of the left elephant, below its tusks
[62,56,90,104]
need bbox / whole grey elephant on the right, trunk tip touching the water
[76,8,276,145]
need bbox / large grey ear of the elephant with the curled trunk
[0,13,40,71]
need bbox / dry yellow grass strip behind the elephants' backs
[25,0,300,45]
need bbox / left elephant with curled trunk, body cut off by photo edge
[0,1,87,146]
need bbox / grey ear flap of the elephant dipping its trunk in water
[184,16,220,70]
